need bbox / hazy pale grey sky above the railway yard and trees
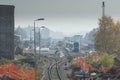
[0,0,120,34]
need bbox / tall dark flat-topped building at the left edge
[0,5,15,59]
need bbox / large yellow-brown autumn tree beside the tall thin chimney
[94,16,117,54]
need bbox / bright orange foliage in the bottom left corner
[0,64,35,80]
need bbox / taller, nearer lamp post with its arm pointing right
[34,18,44,80]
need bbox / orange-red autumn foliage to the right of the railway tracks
[73,54,111,72]
